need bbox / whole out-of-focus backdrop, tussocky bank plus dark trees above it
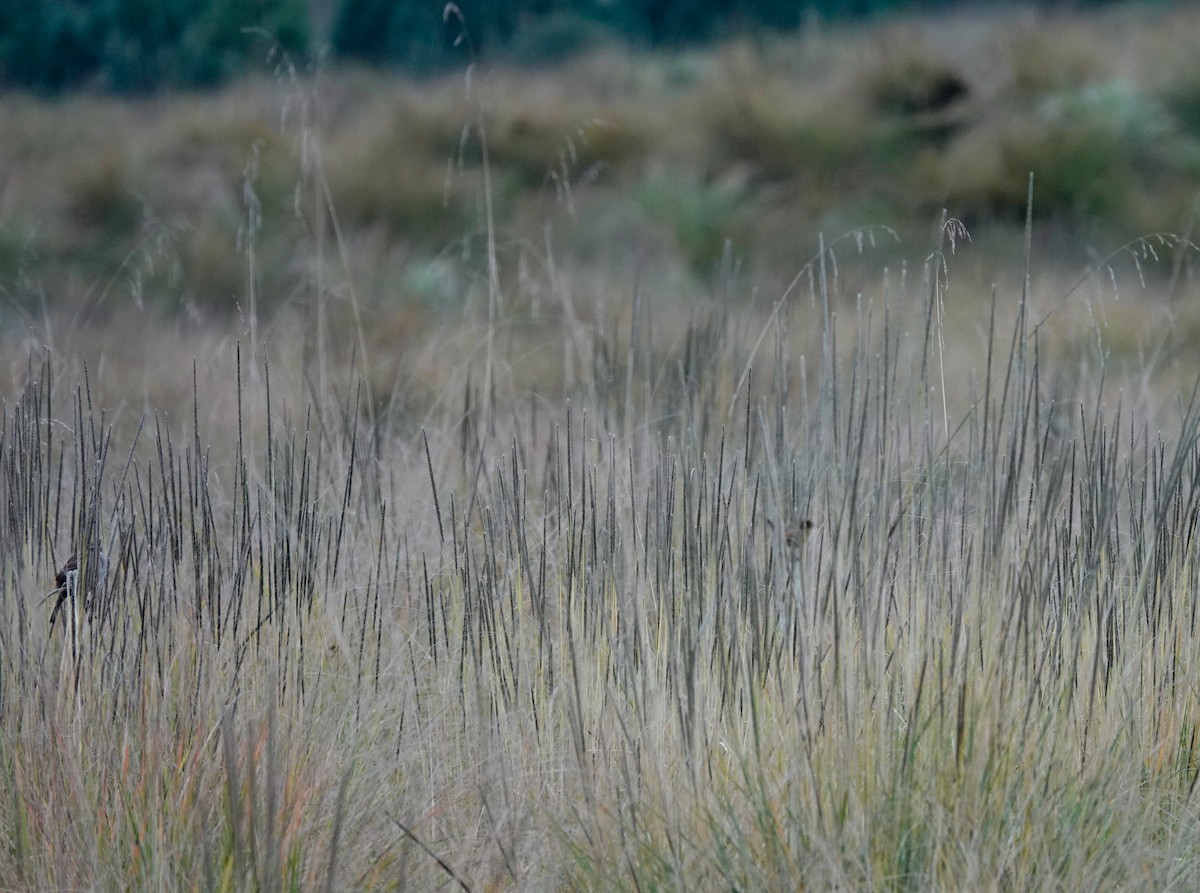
[0,0,1200,348]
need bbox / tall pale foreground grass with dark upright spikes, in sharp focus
[0,204,1200,889]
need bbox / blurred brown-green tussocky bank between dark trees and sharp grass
[0,6,1200,328]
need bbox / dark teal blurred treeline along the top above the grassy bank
[0,0,1097,92]
